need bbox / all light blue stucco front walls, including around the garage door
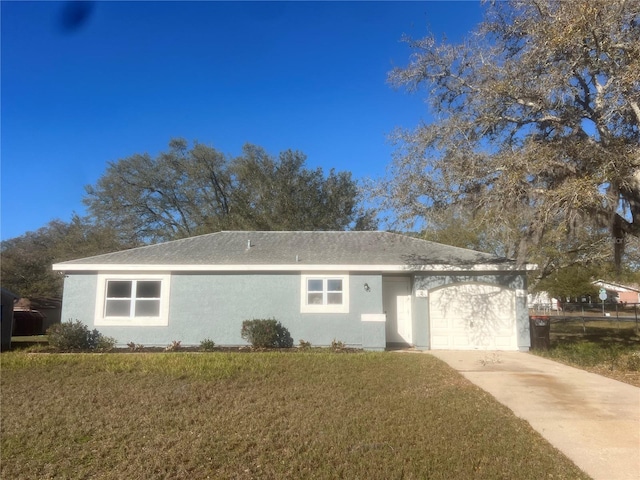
[62,272,530,350]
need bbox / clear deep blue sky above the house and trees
[1,1,482,240]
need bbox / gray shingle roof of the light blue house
[54,231,513,271]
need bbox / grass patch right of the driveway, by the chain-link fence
[532,320,640,387]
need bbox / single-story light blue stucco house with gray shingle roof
[53,231,530,350]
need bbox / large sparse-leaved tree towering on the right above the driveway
[380,0,640,276]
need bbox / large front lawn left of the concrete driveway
[0,352,588,479]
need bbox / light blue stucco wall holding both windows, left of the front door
[62,272,382,346]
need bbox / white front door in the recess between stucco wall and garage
[382,277,413,345]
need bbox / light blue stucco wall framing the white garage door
[413,272,531,351]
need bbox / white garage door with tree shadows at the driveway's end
[429,284,517,350]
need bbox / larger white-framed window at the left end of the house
[95,274,170,326]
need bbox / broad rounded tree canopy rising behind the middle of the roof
[84,139,370,243]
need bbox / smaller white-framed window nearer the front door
[300,274,349,313]
